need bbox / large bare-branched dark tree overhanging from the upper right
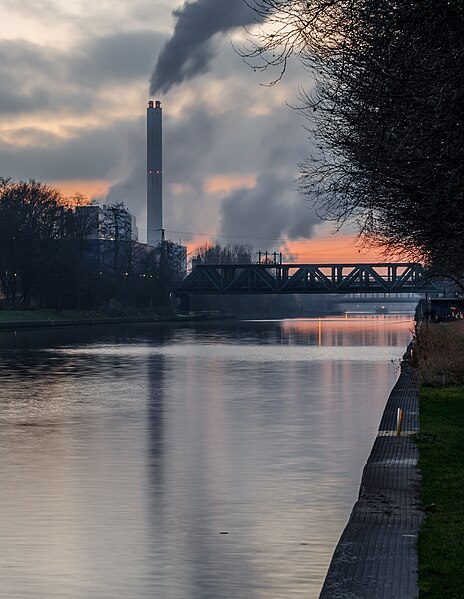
[245,0,464,281]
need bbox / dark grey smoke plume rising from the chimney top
[150,0,257,95]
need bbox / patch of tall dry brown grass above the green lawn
[412,320,464,387]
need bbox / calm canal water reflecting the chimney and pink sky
[0,316,411,599]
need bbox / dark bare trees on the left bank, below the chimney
[0,179,176,310]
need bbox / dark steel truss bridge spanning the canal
[175,263,439,295]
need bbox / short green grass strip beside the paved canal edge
[418,386,464,599]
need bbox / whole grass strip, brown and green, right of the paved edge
[413,322,464,599]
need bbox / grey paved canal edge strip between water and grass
[319,347,424,599]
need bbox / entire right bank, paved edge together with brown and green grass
[320,321,464,599]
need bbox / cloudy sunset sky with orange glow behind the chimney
[0,0,384,262]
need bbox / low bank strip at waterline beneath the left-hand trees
[0,310,233,331]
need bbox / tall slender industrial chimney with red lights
[147,100,163,246]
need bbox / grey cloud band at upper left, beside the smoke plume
[0,30,164,115]
